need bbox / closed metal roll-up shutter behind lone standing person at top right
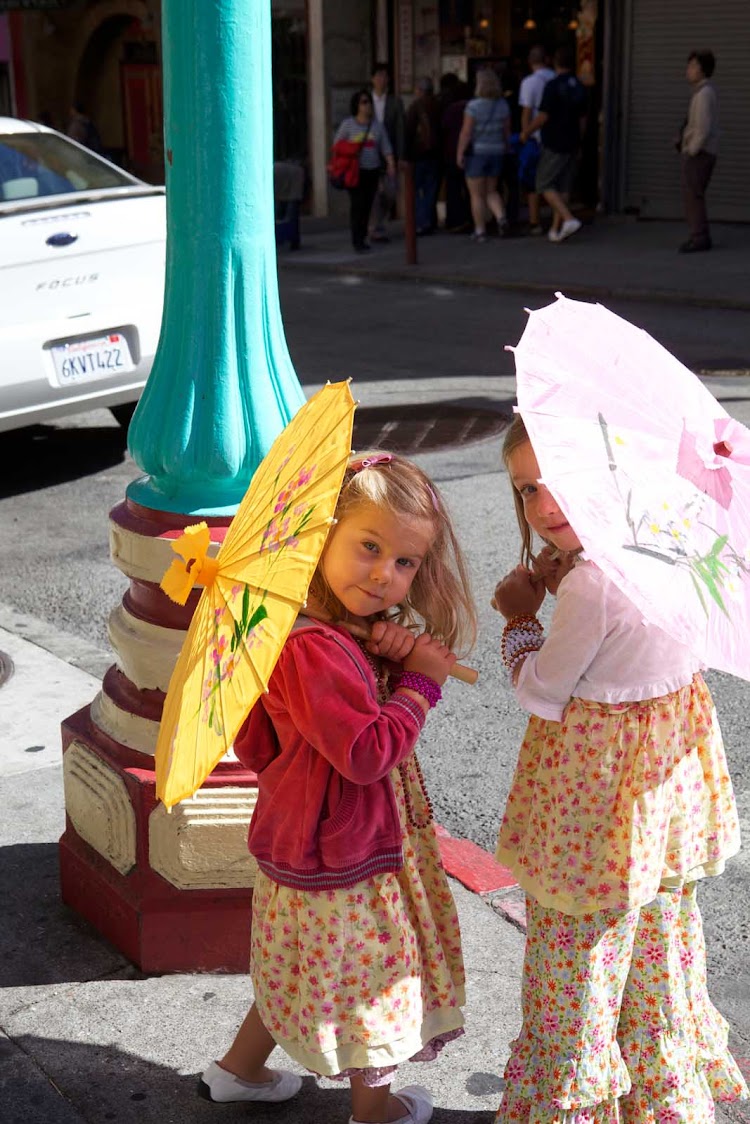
[623,0,750,223]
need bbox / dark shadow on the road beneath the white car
[0,425,127,499]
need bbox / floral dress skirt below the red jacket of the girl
[251,759,464,1085]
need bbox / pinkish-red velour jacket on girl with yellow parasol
[234,617,422,890]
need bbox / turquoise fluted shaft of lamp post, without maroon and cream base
[127,0,305,516]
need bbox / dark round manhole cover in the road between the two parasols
[353,401,513,456]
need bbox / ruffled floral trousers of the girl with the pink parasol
[497,885,750,1124]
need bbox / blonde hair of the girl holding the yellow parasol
[310,450,477,653]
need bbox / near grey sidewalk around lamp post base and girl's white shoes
[0,629,524,1124]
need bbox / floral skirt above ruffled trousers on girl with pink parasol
[497,676,740,915]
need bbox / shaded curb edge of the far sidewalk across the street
[279,257,750,312]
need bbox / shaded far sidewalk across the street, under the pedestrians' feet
[279,216,750,310]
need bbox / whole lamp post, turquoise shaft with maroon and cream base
[60,0,304,972]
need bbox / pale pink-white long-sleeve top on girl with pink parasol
[516,561,702,722]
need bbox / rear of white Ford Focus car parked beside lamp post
[0,117,166,430]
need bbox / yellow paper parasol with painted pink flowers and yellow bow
[156,382,354,808]
